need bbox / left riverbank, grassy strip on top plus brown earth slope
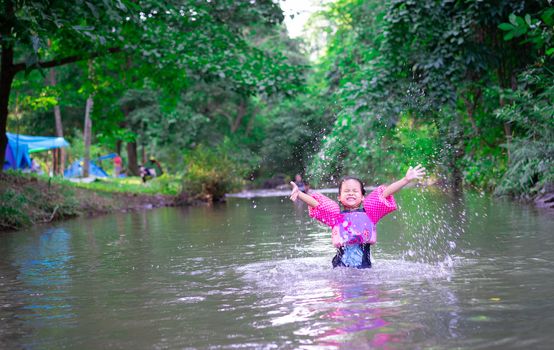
[0,171,182,231]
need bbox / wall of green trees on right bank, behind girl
[302,0,554,198]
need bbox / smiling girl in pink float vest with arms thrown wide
[290,165,425,269]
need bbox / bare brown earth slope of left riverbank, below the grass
[0,173,185,232]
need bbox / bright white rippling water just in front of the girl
[236,258,458,339]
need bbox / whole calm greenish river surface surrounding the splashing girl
[0,189,554,349]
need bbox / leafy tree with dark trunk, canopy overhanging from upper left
[0,0,298,172]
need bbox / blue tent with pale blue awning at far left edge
[3,132,69,169]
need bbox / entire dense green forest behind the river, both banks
[0,0,554,197]
